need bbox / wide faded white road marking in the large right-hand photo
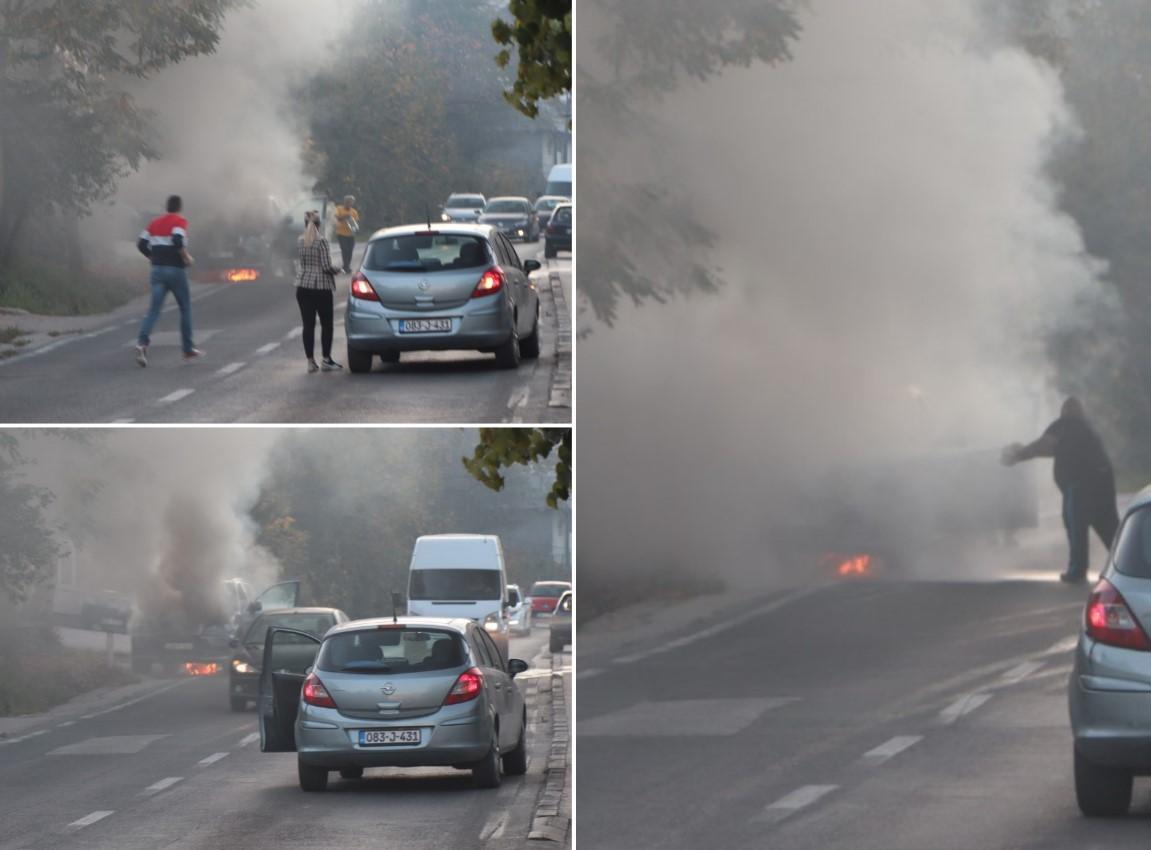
[579,697,796,737]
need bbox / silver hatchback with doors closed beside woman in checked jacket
[344,225,540,372]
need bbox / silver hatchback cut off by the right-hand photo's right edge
[1068,487,1151,817]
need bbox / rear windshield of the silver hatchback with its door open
[315,625,464,675]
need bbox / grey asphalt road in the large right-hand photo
[576,573,1151,850]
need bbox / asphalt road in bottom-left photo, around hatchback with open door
[0,630,551,850]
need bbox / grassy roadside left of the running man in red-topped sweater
[0,265,138,316]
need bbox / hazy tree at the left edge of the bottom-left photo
[0,432,61,602]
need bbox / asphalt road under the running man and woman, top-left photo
[0,241,571,424]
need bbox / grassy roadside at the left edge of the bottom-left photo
[0,627,139,718]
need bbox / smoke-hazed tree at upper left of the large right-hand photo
[577,0,801,324]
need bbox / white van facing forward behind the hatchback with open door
[407,534,508,650]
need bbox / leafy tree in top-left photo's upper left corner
[0,0,246,287]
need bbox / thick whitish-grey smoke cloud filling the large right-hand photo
[579,0,1099,589]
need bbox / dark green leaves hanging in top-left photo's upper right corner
[491,0,572,117]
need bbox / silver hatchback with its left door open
[259,617,527,791]
